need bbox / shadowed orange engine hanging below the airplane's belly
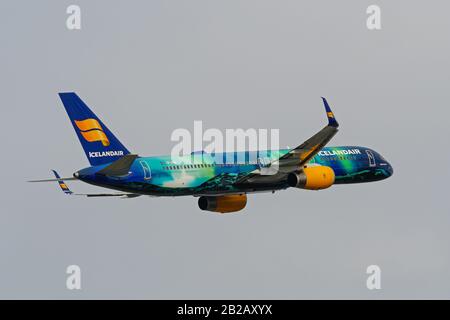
[198,194,247,213]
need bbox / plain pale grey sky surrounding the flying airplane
[0,0,450,299]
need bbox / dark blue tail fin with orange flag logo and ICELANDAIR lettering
[59,92,130,166]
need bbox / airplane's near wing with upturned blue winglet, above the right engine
[238,97,339,183]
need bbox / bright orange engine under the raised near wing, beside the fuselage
[287,166,335,190]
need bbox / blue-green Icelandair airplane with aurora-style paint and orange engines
[30,92,393,213]
